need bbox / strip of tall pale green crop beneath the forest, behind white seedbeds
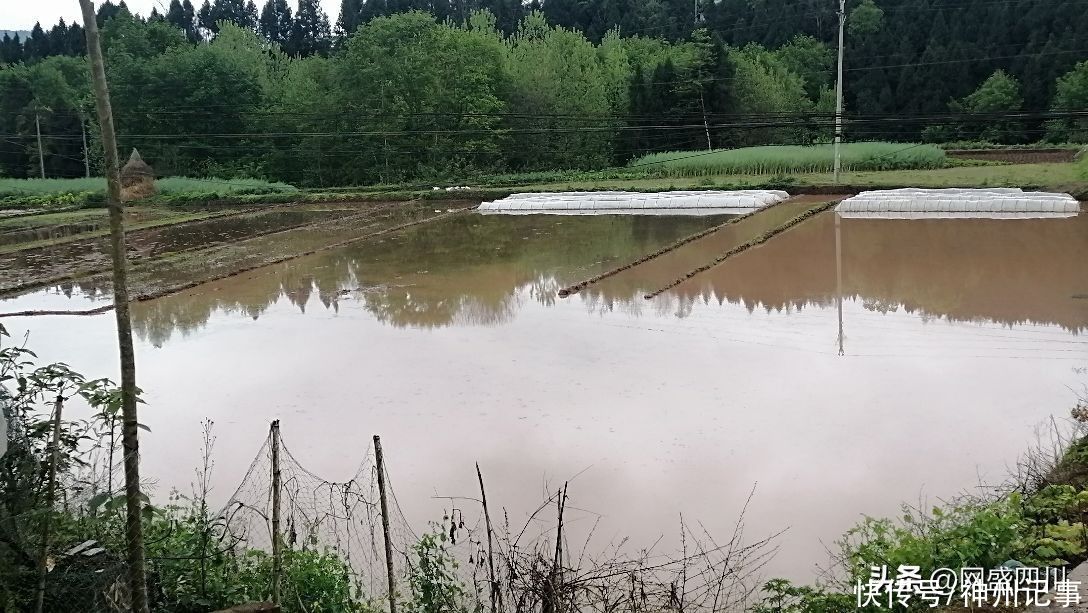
[629,143,945,176]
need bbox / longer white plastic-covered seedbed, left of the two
[480,189,790,214]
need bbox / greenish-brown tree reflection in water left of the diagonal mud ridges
[134,216,712,345]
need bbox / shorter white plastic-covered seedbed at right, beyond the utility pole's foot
[834,187,1080,219]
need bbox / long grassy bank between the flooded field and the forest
[0,150,1088,212]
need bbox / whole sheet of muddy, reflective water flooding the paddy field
[0,205,1088,580]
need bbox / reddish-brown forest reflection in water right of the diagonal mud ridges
[635,216,1088,332]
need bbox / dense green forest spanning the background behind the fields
[0,0,1088,186]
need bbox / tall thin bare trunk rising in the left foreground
[79,0,148,613]
